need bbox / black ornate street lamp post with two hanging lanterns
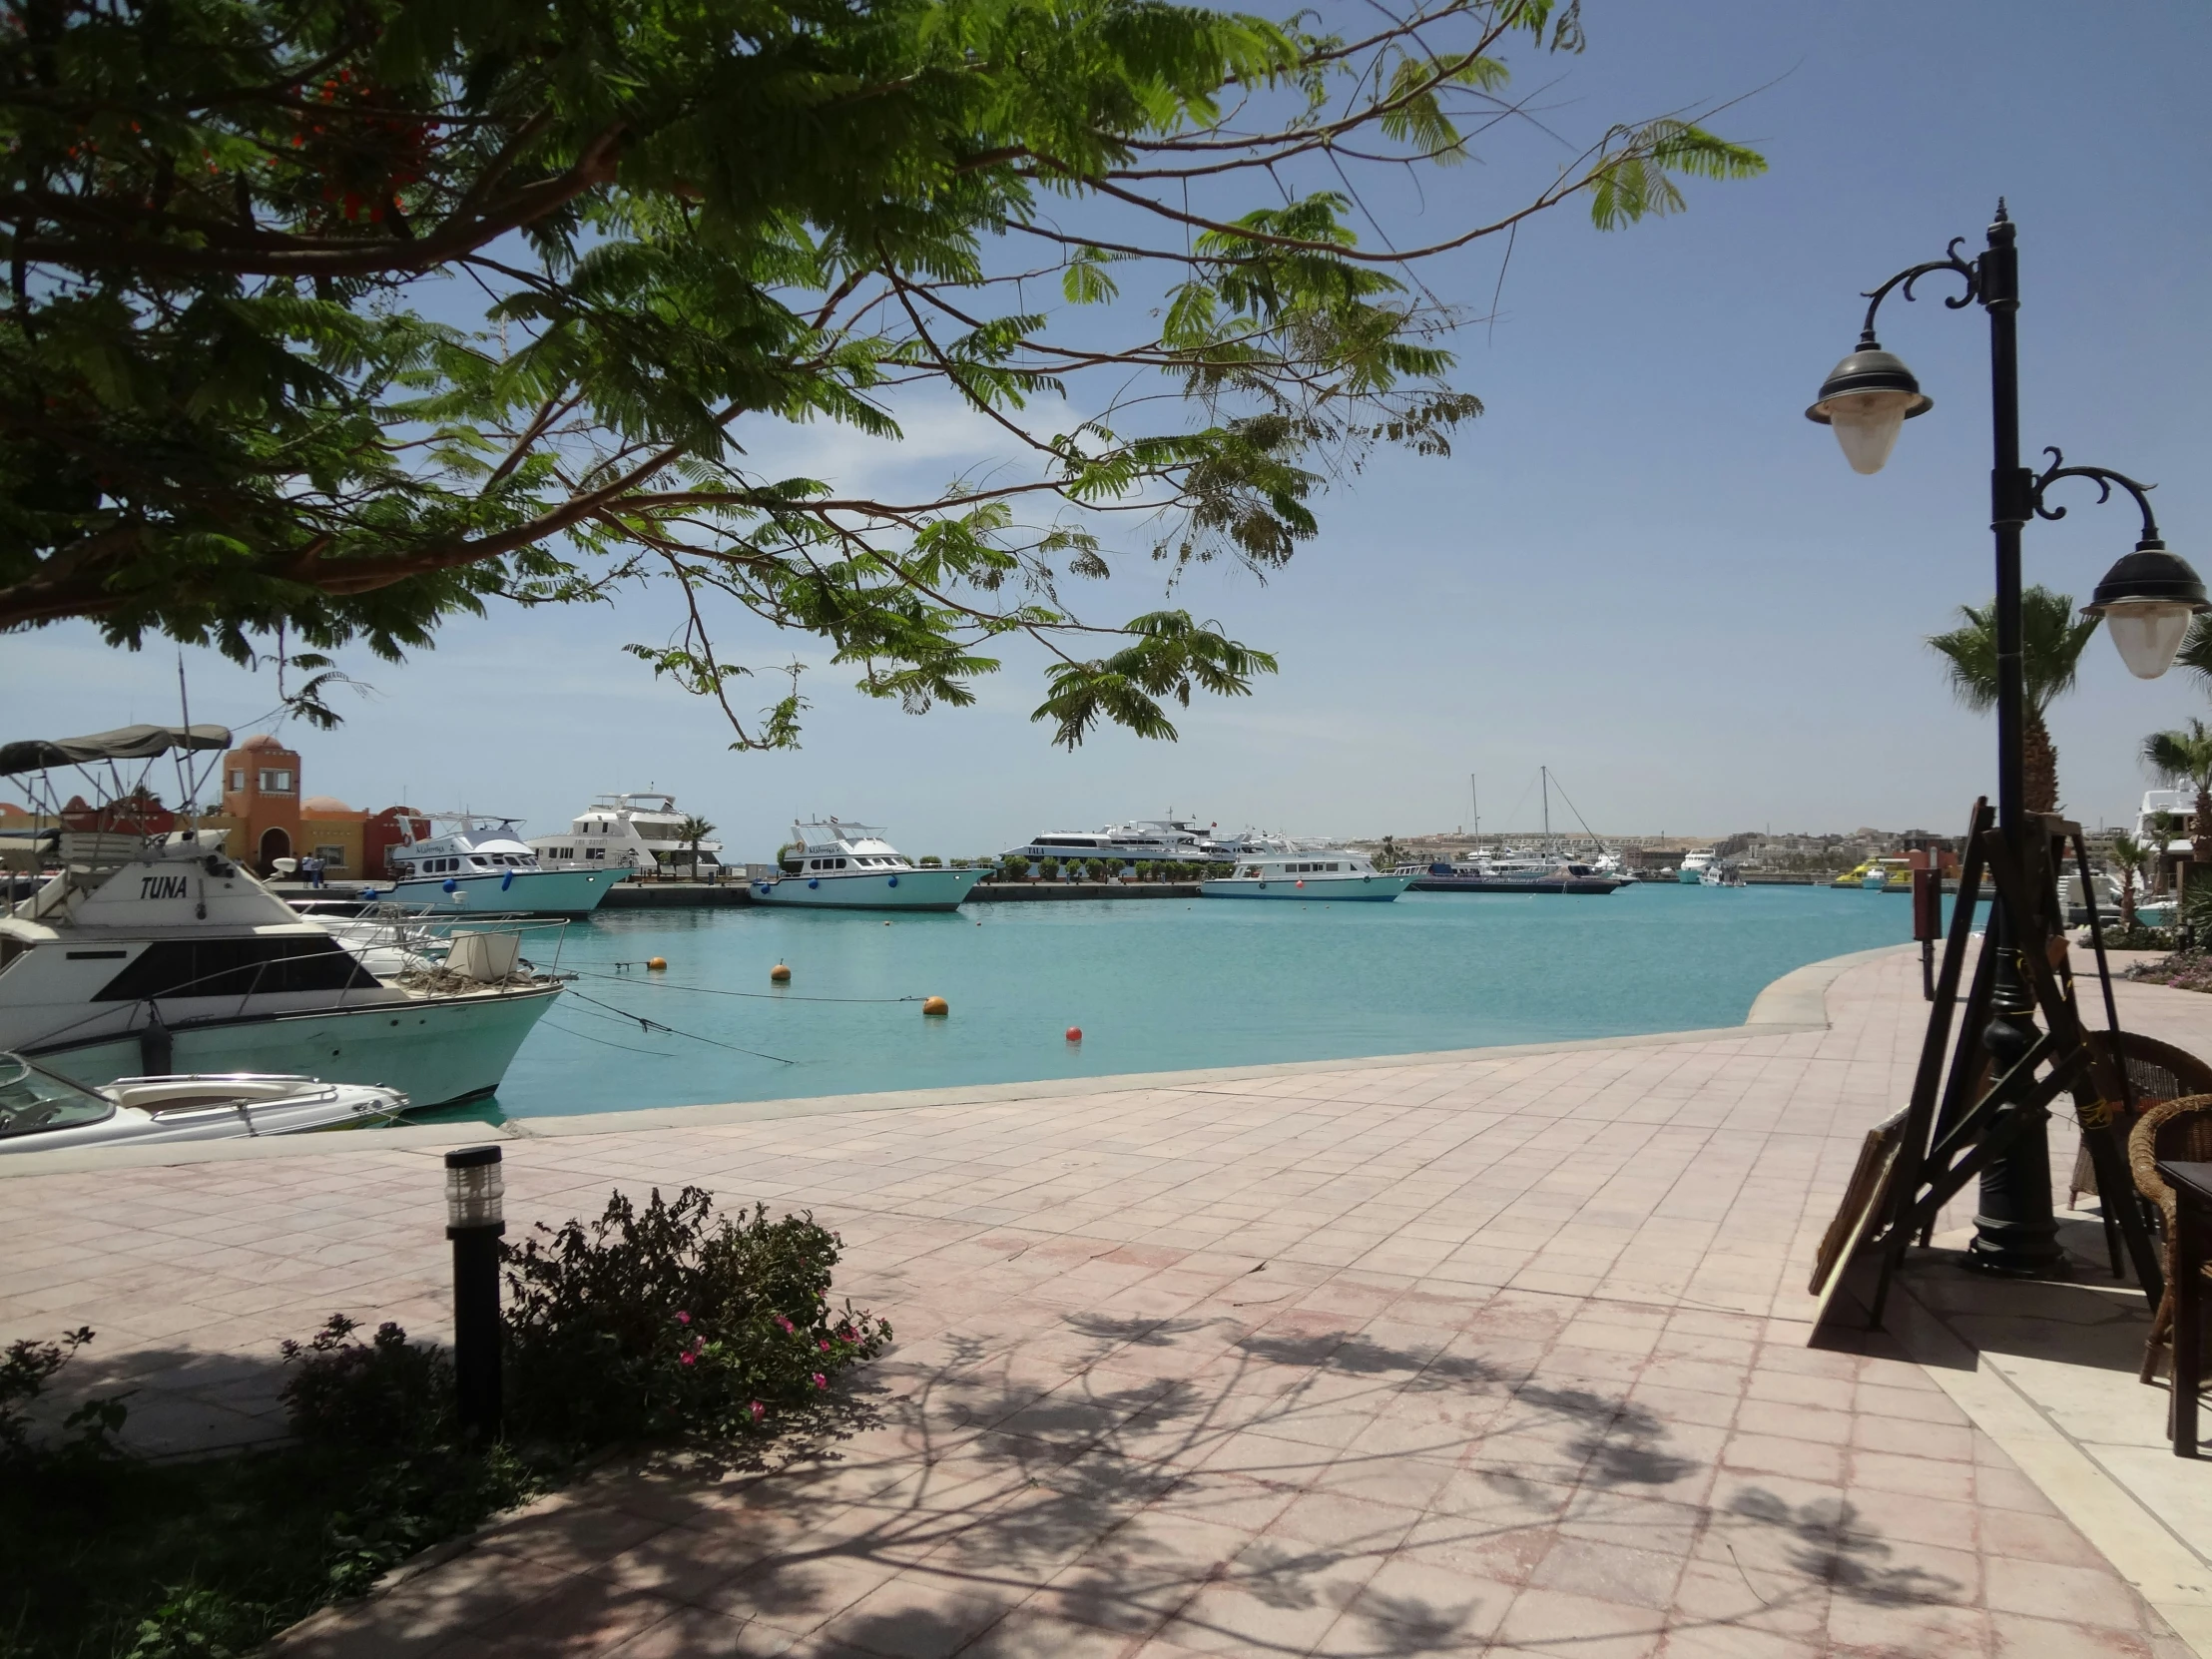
[1805,202,2212,1279]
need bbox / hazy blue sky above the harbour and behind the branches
[0,0,2212,858]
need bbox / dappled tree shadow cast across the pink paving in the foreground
[462,1314,1962,1655]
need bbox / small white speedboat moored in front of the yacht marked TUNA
[0,1053,409,1155]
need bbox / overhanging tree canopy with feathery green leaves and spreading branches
[0,0,1763,748]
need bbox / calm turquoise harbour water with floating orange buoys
[464,884,1990,1117]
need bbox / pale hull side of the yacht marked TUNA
[22,984,560,1106]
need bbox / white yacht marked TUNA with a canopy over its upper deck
[0,726,562,1106]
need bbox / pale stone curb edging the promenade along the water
[0,944,1914,1179]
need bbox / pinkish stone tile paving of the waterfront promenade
[0,955,2212,1659]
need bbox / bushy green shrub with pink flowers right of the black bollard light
[506,1186,891,1444]
